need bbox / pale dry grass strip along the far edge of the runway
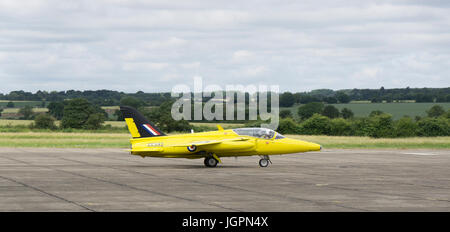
[0,132,450,149]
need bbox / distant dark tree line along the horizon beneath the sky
[0,87,450,107]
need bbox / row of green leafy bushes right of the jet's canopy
[250,102,450,138]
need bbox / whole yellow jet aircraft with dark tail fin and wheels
[120,106,322,167]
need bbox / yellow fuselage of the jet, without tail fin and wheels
[131,130,321,159]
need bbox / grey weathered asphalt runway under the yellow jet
[0,148,450,211]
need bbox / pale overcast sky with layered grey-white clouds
[0,0,450,93]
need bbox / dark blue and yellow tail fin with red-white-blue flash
[120,106,165,138]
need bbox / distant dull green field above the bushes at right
[280,103,450,119]
